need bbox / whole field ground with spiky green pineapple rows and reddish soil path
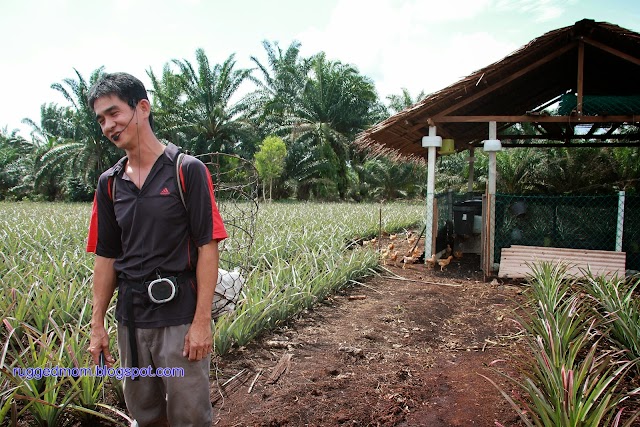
[0,202,640,426]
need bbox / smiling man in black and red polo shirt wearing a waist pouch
[87,73,227,427]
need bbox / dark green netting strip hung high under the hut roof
[558,94,640,116]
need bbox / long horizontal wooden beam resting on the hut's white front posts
[433,115,640,125]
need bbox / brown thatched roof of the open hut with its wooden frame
[356,19,640,158]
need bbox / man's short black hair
[87,73,153,128]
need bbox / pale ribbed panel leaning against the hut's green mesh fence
[498,245,626,279]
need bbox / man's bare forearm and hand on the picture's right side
[182,239,219,361]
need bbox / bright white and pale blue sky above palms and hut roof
[0,0,640,137]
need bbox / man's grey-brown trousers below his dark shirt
[118,323,212,427]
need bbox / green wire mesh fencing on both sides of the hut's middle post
[435,192,640,271]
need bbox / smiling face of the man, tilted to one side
[93,95,136,149]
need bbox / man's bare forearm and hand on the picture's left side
[89,255,116,367]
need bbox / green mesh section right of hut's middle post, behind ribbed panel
[495,194,640,270]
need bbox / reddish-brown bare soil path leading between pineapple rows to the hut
[211,236,523,427]
